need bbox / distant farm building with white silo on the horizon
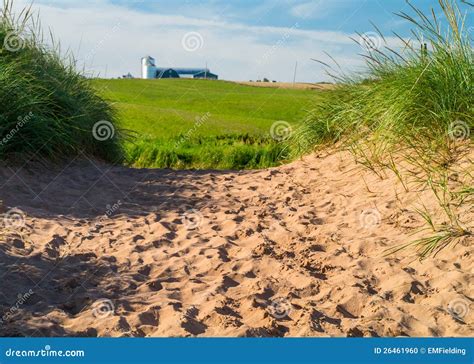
[142,56,218,80]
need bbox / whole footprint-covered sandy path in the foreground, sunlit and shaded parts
[0,152,474,337]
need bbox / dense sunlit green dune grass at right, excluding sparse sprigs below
[295,0,474,159]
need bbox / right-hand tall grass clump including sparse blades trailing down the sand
[293,0,474,257]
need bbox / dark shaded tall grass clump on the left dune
[0,0,123,162]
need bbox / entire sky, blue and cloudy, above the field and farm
[15,0,472,82]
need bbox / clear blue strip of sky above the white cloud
[112,0,437,33]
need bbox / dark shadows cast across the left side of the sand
[0,158,241,336]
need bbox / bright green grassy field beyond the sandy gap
[94,79,323,169]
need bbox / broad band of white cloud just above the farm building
[11,0,386,82]
